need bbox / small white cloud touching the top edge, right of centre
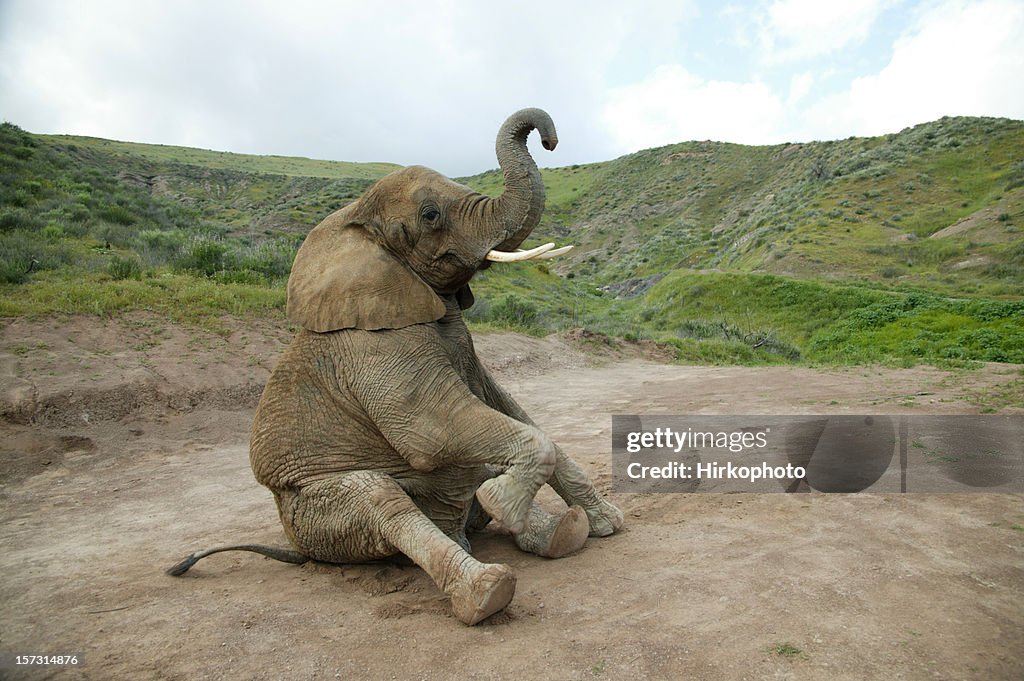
[760,0,886,62]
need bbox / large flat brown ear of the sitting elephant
[288,221,444,333]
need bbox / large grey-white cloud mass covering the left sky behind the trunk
[0,0,692,175]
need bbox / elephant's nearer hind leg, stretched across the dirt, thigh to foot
[279,471,515,625]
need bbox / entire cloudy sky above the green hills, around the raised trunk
[0,0,1024,175]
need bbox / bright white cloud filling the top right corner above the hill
[805,0,1024,137]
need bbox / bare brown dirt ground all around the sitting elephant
[0,315,1024,680]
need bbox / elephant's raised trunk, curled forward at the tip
[493,109,558,251]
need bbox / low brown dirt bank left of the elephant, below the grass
[0,313,292,428]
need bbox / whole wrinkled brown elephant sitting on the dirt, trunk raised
[168,109,623,625]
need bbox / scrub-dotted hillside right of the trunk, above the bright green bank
[468,118,1024,296]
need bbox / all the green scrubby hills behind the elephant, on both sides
[0,119,1024,364]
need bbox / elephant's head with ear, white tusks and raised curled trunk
[288,109,567,333]
